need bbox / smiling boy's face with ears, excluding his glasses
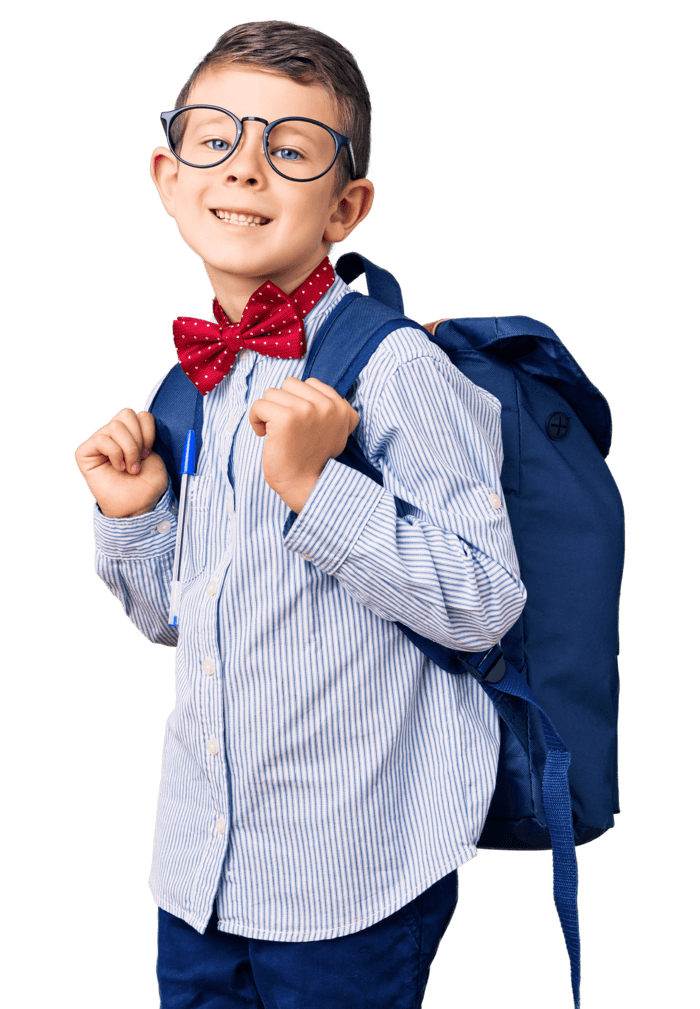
[151,67,373,293]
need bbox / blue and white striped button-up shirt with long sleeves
[94,268,526,942]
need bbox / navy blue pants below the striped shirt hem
[155,869,459,1009]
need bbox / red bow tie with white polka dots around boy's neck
[172,258,335,394]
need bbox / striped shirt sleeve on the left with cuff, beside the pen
[93,481,178,647]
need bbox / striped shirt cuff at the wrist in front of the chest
[283,459,386,574]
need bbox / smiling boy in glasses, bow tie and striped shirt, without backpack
[76,21,524,1009]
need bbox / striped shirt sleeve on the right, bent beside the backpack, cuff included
[284,331,527,651]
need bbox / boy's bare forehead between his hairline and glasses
[187,67,340,130]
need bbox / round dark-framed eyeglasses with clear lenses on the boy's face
[160,105,355,183]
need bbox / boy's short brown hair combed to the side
[174,21,372,194]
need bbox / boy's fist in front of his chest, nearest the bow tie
[248,378,360,513]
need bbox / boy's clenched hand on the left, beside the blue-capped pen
[76,407,167,519]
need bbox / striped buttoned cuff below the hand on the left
[93,480,178,557]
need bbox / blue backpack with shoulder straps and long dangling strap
[151,252,624,1009]
